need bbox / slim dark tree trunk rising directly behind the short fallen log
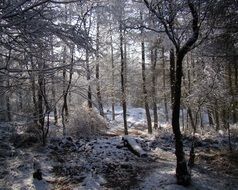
[119,21,128,135]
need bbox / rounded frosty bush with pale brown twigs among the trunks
[68,106,107,137]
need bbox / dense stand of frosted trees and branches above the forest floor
[0,0,238,189]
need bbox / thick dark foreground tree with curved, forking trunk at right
[144,0,205,185]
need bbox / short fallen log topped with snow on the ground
[122,136,148,157]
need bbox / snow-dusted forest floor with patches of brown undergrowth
[0,107,238,190]
